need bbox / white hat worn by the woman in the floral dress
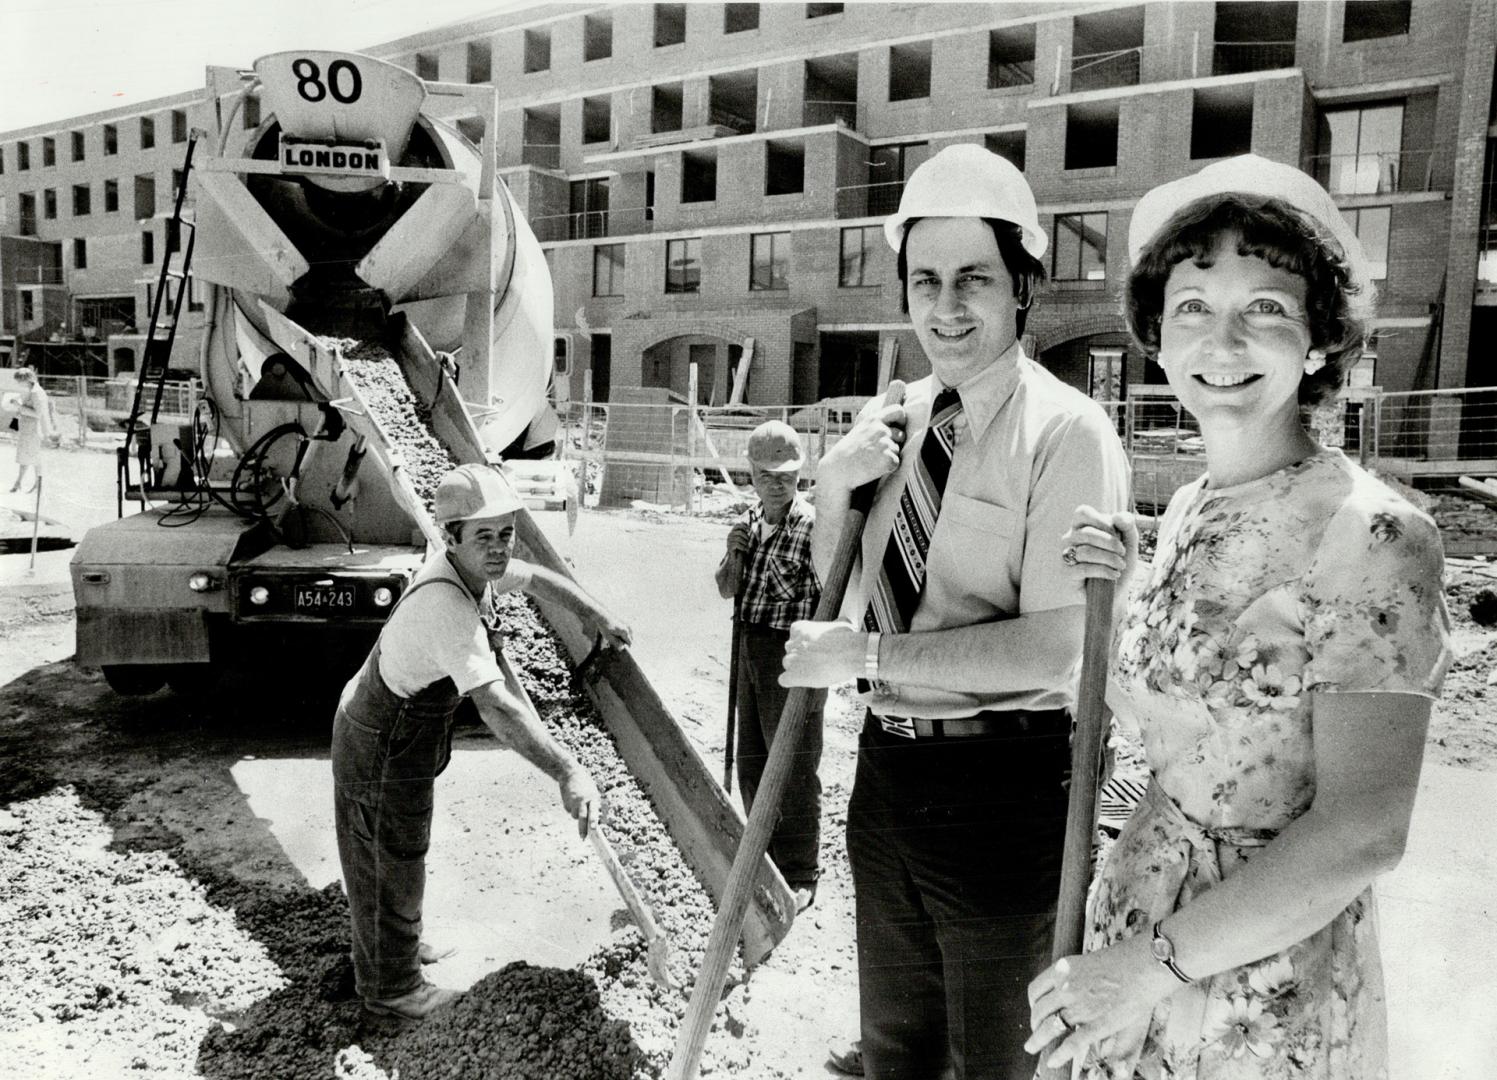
[1127,154,1371,288]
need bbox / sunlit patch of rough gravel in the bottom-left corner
[0,788,286,1080]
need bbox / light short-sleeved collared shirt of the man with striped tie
[841,343,1129,719]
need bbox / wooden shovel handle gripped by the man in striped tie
[666,380,904,1080]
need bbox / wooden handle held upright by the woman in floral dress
[1037,578,1114,1080]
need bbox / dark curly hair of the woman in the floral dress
[1124,192,1373,406]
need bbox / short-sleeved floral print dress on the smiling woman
[1085,449,1451,1080]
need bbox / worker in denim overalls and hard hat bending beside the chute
[332,464,630,1020]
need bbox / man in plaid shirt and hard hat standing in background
[716,419,826,911]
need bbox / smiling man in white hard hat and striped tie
[784,145,1129,1080]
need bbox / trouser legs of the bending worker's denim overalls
[332,686,452,999]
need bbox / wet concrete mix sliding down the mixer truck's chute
[338,339,742,1077]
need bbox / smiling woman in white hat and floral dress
[1030,156,1451,1079]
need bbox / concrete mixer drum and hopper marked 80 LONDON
[193,51,552,452]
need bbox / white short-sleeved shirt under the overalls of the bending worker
[379,551,531,698]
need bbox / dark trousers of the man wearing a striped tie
[847,710,1070,1080]
